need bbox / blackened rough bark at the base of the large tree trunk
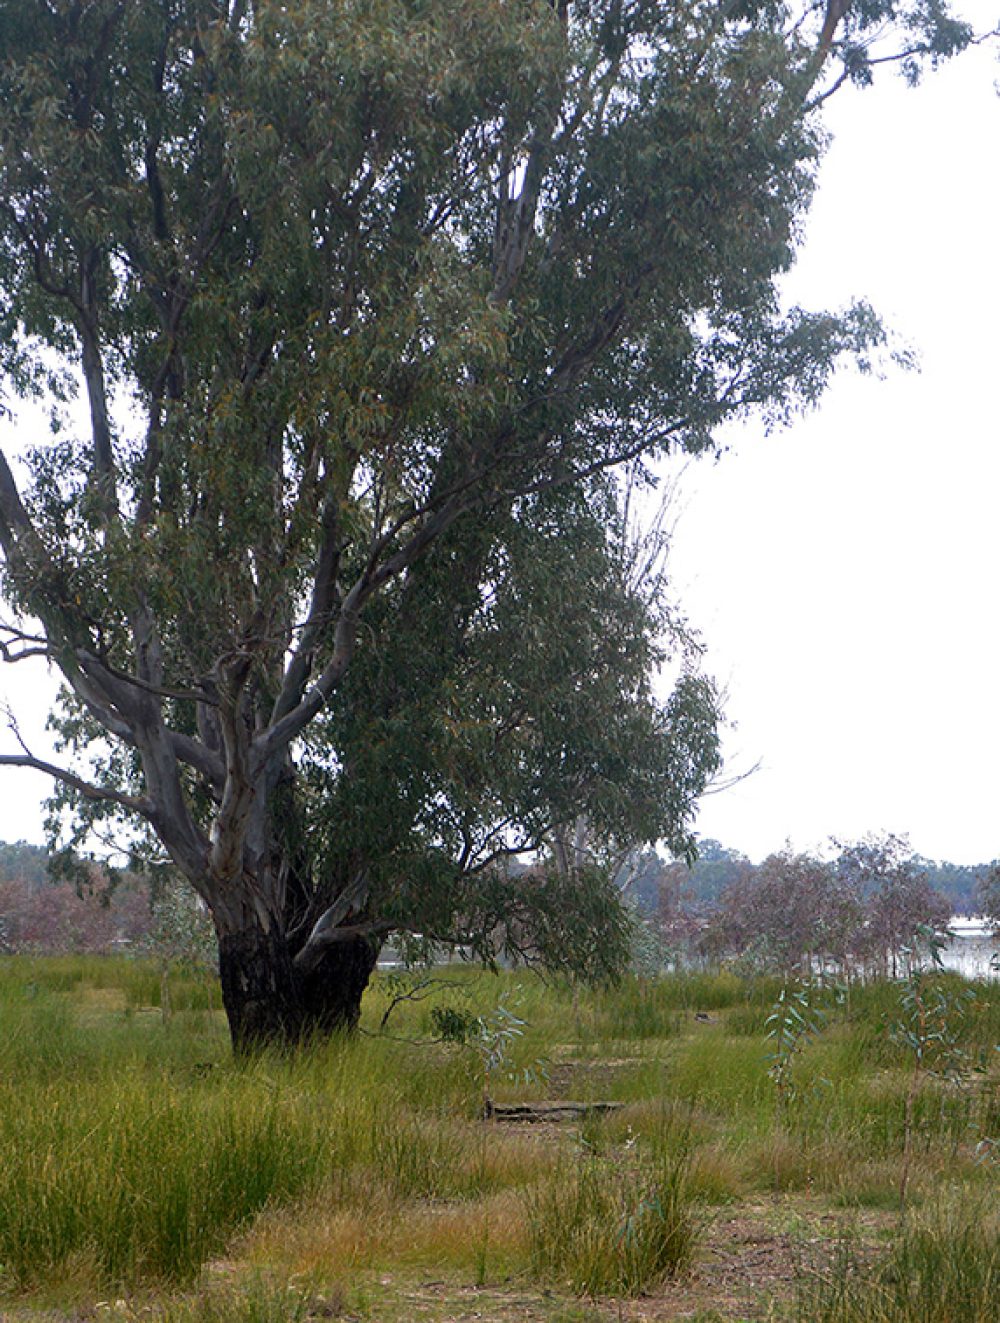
[218,927,378,1056]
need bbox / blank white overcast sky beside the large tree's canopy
[0,12,1000,863]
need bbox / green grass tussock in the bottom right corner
[798,1207,1000,1323]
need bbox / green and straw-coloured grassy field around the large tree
[0,957,1000,1323]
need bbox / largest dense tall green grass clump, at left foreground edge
[0,1077,332,1289]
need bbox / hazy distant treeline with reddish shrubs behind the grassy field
[0,835,1000,974]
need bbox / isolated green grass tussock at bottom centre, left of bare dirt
[525,1152,698,1297]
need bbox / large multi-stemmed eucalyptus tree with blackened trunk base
[0,0,970,1048]
